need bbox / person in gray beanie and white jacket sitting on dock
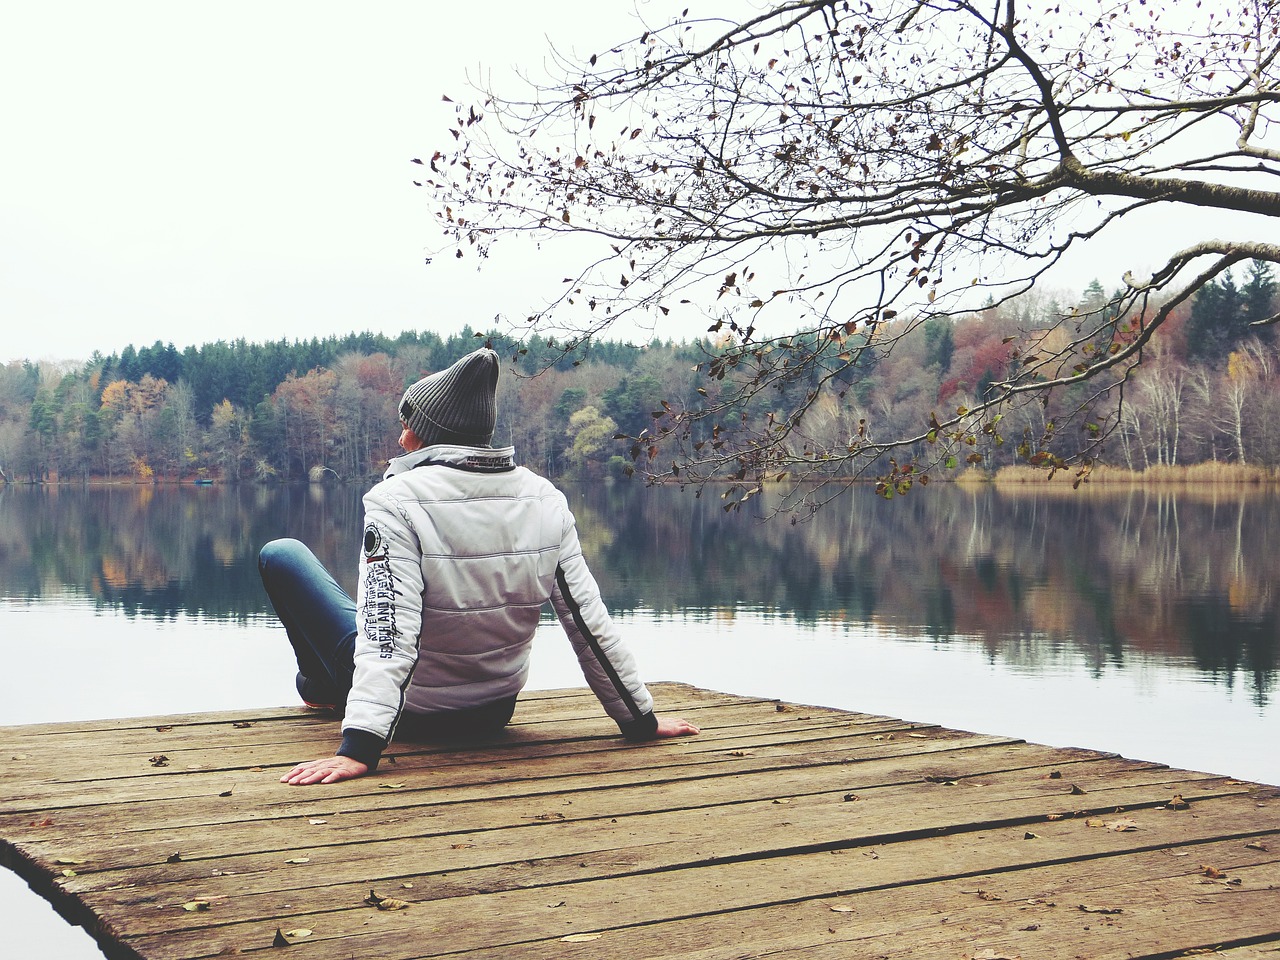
[259,348,699,785]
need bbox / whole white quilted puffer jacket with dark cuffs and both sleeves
[339,445,657,767]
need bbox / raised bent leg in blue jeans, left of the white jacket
[257,540,356,707]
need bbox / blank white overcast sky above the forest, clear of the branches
[0,0,1269,364]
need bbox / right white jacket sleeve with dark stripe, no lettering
[552,504,658,740]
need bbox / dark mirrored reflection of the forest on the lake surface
[0,484,1280,705]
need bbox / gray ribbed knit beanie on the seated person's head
[399,347,498,447]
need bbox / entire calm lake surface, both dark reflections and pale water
[0,485,1280,957]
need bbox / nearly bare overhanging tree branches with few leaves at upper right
[430,0,1280,512]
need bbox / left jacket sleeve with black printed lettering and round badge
[338,492,422,769]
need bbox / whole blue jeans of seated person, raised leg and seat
[257,540,516,737]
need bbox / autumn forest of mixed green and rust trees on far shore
[0,261,1280,483]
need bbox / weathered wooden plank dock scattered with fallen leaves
[0,684,1280,960]
